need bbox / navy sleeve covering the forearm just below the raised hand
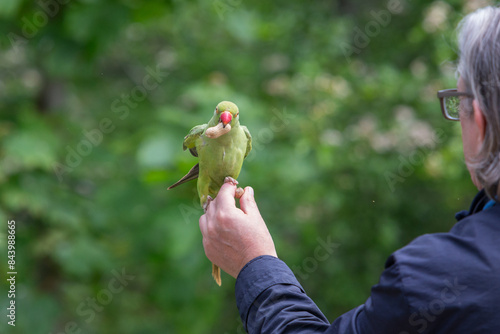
[236,256,330,333]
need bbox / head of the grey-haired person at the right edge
[457,7,500,199]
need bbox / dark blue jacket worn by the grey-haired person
[235,191,500,334]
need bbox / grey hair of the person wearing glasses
[457,6,500,201]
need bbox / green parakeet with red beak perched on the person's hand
[168,101,252,285]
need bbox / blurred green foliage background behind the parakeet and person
[0,0,489,334]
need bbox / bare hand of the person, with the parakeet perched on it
[200,183,277,278]
